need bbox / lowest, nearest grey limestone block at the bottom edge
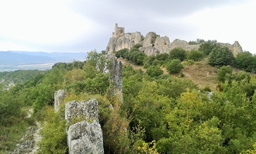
[67,120,104,154]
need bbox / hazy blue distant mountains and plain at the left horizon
[0,51,87,72]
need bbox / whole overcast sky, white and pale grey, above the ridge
[0,0,256,54]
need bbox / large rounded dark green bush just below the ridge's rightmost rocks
[208,46,235,67]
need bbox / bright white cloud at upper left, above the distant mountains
[0,0,95,44]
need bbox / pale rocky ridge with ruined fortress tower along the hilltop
[106,24,243,56]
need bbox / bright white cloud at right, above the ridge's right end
[184,1,256,53]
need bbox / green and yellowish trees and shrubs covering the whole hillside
[0,42,256,154]
